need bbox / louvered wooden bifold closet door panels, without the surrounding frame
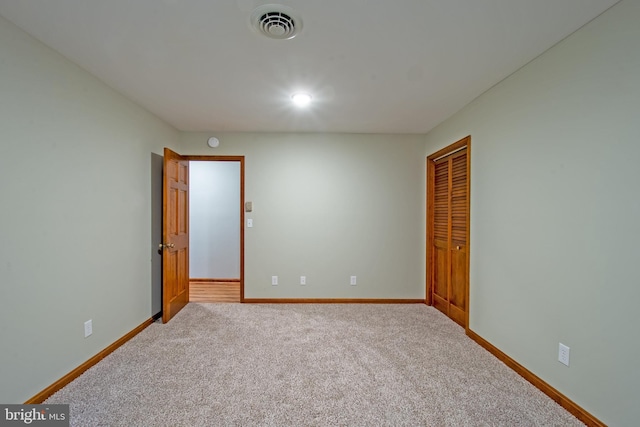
[432,149,468,326]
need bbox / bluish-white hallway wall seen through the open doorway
[189,161,240,279]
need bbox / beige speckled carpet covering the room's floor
[46,303,583,427]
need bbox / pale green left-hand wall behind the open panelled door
[0,18,179,403]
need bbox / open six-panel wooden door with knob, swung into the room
[162,148,189,323]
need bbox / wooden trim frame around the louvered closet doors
[425,135,471,330]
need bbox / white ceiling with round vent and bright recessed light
[0,0,617,133]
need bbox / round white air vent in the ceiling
[251,4,302,40]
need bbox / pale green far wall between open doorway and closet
[182,133,425,298]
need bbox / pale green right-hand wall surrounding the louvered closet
[425,0,640,426]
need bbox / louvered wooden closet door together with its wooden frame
[427,137,470,327]
